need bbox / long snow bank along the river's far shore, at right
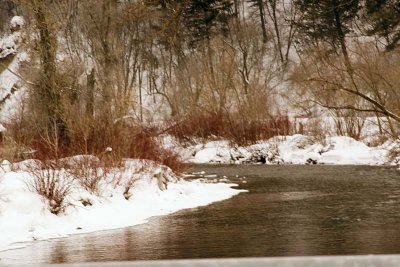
[171,134,390,165]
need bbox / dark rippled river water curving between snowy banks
[0,165,400,265]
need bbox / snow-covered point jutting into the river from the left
[0,158,243,253]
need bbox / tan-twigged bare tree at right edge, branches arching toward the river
[292,41,400,139]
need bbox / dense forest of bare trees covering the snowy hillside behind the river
[0,0,400,162]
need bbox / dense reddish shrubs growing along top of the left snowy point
[23,123,182,174]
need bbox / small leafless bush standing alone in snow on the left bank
[28,162,73,215]
